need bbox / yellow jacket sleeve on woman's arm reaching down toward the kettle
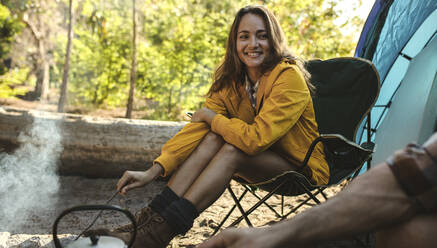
[153,93,227,176]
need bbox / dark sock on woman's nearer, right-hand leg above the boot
[161,197,199,234]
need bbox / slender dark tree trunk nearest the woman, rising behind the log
[126,0,137,119]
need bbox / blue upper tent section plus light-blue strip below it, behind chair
[355,0,437,142]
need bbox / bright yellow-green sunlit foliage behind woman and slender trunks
[0,0,363,120]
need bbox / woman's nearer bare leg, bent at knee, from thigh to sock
[184,143,297,212]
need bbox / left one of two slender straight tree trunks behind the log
[58,0,73,112]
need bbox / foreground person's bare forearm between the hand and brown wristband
[270,165,414,247]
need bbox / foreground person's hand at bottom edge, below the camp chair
[197,228,274,248]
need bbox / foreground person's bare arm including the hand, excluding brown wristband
[199,133,437,248]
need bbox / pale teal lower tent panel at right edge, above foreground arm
[373,39,437,164]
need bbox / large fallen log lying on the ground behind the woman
[0,106,185,178]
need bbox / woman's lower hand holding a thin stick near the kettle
[117,164,164,195]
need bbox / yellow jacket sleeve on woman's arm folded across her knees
[211,68,311,155]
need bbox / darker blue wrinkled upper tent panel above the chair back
[355,0,437,81]
